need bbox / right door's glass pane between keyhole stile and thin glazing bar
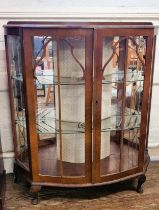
[100,36,124,175]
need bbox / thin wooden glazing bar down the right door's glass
[119,37,129,172]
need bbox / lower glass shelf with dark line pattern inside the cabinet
[16,108,141,134]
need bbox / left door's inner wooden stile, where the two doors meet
[85,31,93,182]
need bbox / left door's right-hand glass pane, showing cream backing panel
[55,37,85,175]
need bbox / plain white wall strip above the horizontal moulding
[0,0,159,11]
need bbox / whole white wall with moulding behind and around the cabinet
[0,0,159,172]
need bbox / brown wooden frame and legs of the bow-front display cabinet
[4,22,156,203]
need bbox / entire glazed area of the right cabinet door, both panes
[100,36,146,175]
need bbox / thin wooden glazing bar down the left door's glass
[57,38,63,177]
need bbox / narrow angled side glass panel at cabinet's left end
[7,36,29,170]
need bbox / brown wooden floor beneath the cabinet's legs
[6,162,159,210]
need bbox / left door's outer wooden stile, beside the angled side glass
[23,30,39,182]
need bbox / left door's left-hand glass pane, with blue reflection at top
[33,36,60,176]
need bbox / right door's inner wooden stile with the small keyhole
[92,29,102,183]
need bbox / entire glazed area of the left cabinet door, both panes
[33,33,91,177]
